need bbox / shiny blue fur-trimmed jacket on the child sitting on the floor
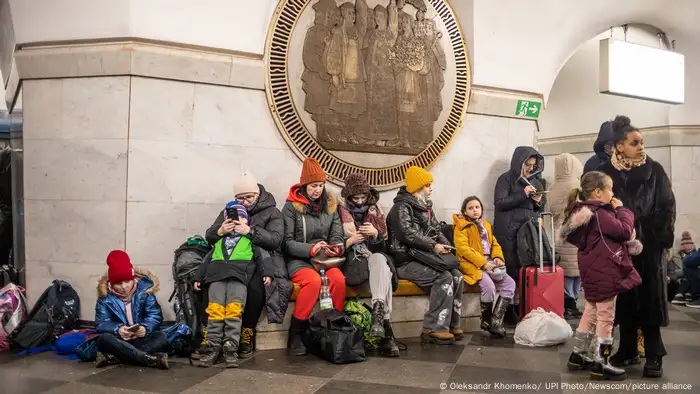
[95,268,163,335]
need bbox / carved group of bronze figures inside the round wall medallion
[302,0,447,155]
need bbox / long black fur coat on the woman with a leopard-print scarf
[598,157,676,327]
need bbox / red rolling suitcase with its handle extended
[519,213,564,318]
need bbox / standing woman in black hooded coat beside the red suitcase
[493,146,544,324]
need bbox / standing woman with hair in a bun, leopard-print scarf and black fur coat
[599,116,676,377]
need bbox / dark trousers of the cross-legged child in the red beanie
[97,331,168,366]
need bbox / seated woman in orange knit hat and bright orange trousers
[282,158,345,356]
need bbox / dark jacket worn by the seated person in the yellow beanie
[386,186,452,267]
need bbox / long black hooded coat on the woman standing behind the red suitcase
[493,146,544,265]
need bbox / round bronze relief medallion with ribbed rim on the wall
[265,0,471,190]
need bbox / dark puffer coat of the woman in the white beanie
[206,185,294,323]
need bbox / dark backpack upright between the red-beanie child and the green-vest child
[168,236,211,356]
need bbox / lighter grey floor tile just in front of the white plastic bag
[457,346,561,373]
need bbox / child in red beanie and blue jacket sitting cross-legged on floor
[95,250,169,369]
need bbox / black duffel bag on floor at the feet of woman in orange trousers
[302,308,367,364]
